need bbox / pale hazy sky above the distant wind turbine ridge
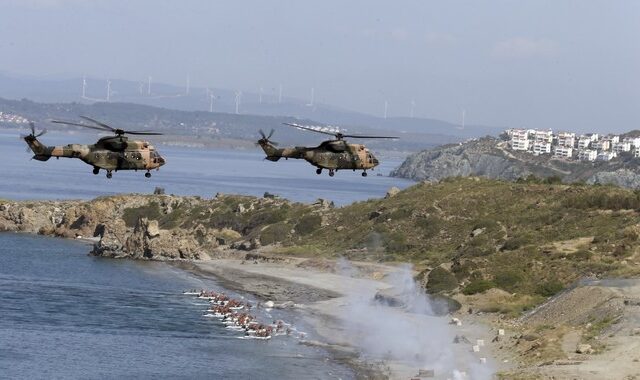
[0,0,640,131]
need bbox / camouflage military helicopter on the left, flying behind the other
[21,116,166,178]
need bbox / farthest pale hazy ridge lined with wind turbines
[0,73,504,140]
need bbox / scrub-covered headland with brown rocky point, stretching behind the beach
[0,177,640,313]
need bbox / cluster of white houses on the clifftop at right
[504,128,640,161]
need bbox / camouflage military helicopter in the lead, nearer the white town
[258,123,397,177]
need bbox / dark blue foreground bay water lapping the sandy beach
[0,233,353,379]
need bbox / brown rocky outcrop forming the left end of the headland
[0,195,304,260]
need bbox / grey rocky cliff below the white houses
[391,137,640,189]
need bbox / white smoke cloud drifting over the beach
[338,260,493,380]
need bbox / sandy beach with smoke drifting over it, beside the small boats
[180,258,499,379]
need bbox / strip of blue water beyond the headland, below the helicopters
[0,132,413,205]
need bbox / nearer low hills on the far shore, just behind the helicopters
[0,98,458,152]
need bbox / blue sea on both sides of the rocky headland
[0,132,412,379]
